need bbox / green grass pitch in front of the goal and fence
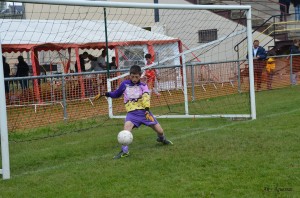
[0,86,300,198]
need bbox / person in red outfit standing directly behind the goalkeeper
[141,54,160,96]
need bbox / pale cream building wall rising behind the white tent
[25,0,272,62]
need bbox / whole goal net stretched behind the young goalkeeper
[0,0,256,179]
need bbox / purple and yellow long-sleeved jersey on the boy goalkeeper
[109,80,150,112]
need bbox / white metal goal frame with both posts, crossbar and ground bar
[0,0,256,179]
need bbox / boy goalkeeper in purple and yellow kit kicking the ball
[105,65,173,159]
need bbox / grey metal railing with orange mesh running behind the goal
[5,56,300,131]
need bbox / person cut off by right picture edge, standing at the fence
[290,39,300,85]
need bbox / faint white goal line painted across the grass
[12,108,300,178]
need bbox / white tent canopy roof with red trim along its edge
[0,19,178,52]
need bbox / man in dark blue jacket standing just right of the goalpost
[247,40,267,91]
